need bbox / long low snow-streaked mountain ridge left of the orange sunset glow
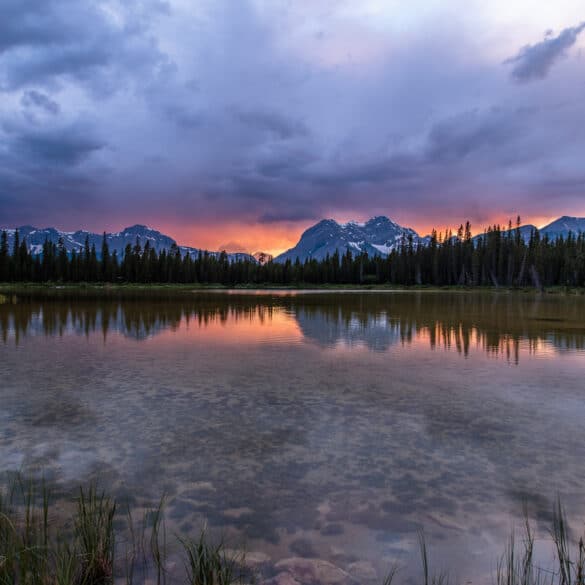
[0,224,256,262]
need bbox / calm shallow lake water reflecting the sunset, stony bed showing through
[0,292,585,582]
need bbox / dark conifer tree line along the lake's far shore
[0,218,585,288]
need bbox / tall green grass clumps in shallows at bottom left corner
[0,477,243,585]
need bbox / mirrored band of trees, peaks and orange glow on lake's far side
[0,293,585,363]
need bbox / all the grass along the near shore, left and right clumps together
[0,477,585,585]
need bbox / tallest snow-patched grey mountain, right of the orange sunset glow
[275,216,428,262]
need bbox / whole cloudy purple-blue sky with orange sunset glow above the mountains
[0,0,585,253]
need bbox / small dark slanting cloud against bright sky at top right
[504,22,585,83]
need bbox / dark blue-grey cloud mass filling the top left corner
[0,0,165,93]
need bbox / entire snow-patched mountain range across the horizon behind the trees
[0,215,585,264]
